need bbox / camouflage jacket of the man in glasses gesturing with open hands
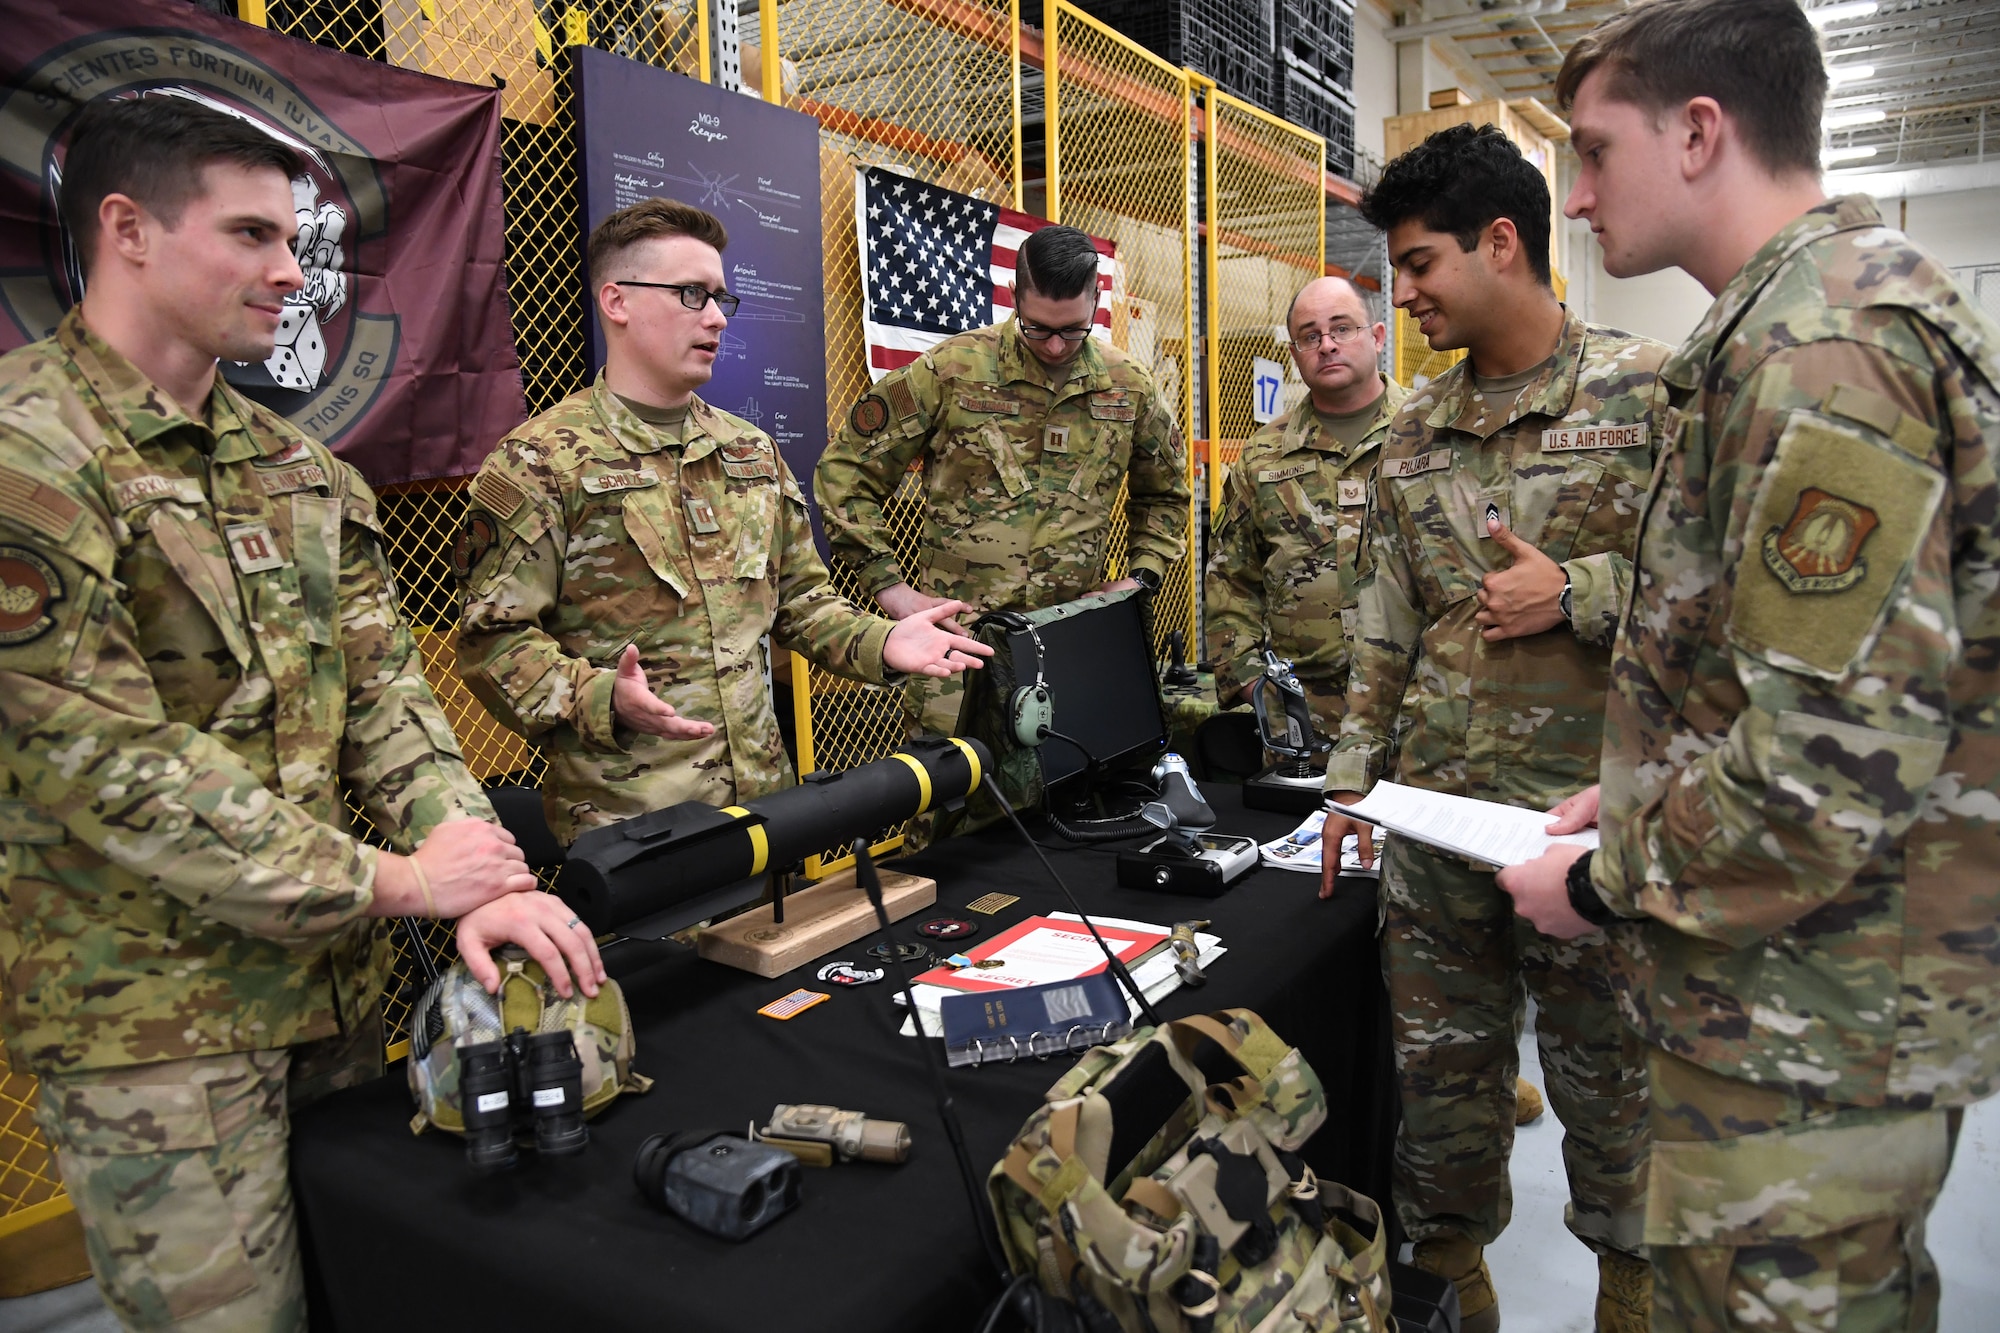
[458,376,902,843]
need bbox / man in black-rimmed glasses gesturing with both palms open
[456,198,990,843]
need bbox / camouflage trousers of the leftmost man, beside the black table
[36,1019,382,1333]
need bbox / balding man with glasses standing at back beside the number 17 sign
[1206,278,1408,737]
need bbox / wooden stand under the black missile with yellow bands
[694,867,938,977]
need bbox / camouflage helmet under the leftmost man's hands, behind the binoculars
[410,947,652,1135]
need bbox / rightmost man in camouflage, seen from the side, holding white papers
[1508,0,2000,1329]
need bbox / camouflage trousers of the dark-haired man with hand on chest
[1382,839,1646,1253]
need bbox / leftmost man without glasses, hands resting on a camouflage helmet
[0,98,584,1329]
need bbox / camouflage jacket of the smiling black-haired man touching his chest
[1326,312,1668,809]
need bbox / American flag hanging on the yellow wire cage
[854,166,1116,380]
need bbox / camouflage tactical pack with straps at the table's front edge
[986,1009,1394,1333]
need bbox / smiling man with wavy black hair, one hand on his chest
[1326,126,1668,1327]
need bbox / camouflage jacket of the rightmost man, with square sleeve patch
[1592,196,2000,1111]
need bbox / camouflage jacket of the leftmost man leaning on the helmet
[0,310,492,1071]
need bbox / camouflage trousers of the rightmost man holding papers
[1646,1049,1962,1333]
